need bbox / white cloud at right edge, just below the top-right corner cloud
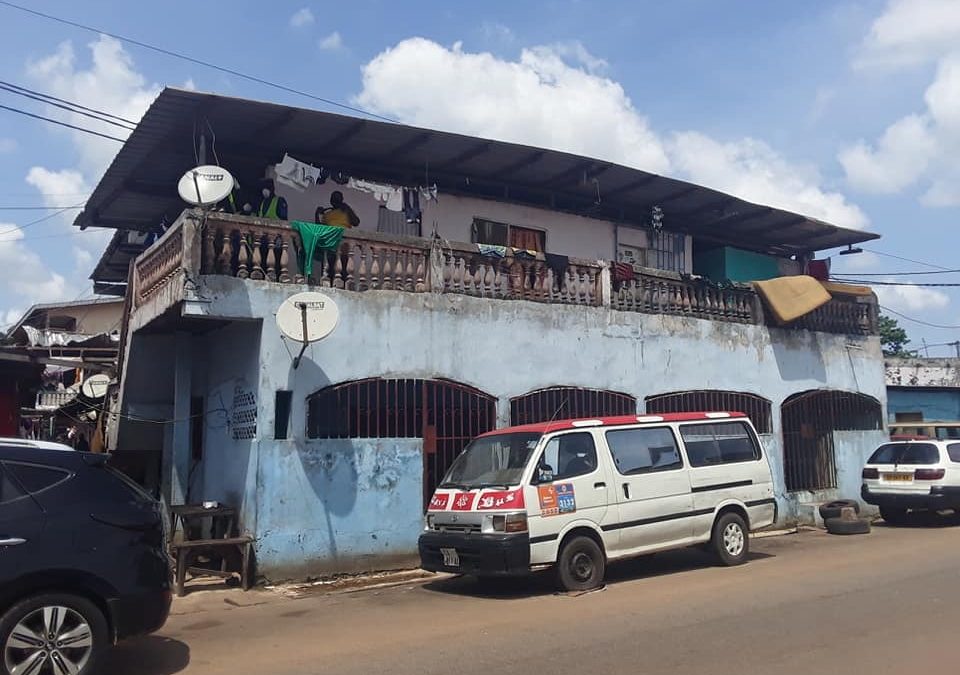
[838,51,960,202]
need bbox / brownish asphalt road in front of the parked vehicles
[109,523,960,675]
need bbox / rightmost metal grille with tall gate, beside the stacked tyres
[780,390,883,492]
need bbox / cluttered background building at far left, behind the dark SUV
[0,298,124,450]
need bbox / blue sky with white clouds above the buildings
[0,0,960,356]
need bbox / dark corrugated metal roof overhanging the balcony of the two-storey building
[74,88,879,281]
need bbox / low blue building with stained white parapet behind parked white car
[885,357,960,424]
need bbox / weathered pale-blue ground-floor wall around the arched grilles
[146,277,885,578]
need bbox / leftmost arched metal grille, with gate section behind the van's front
[307,379,497,499]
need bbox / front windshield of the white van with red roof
[438,433,540,490]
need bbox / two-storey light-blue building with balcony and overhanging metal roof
[76,89,885,579]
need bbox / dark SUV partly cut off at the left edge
[0,439,171,675]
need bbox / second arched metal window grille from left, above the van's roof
[510,387,637,425]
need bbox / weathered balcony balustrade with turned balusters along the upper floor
[128,211,878,336]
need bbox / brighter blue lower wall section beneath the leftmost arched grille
[257,439,423,578]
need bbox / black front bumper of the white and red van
[418,531,530,576]
